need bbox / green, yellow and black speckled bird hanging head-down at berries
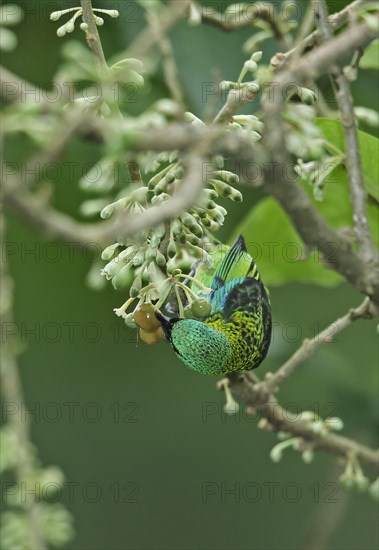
[155,235,272,376]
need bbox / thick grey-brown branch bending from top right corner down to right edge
[263,16,379,303]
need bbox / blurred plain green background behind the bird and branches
[3,0,378,550]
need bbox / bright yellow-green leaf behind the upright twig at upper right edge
[316,118,379,202]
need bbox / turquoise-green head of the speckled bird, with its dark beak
[156,313,232,375]
